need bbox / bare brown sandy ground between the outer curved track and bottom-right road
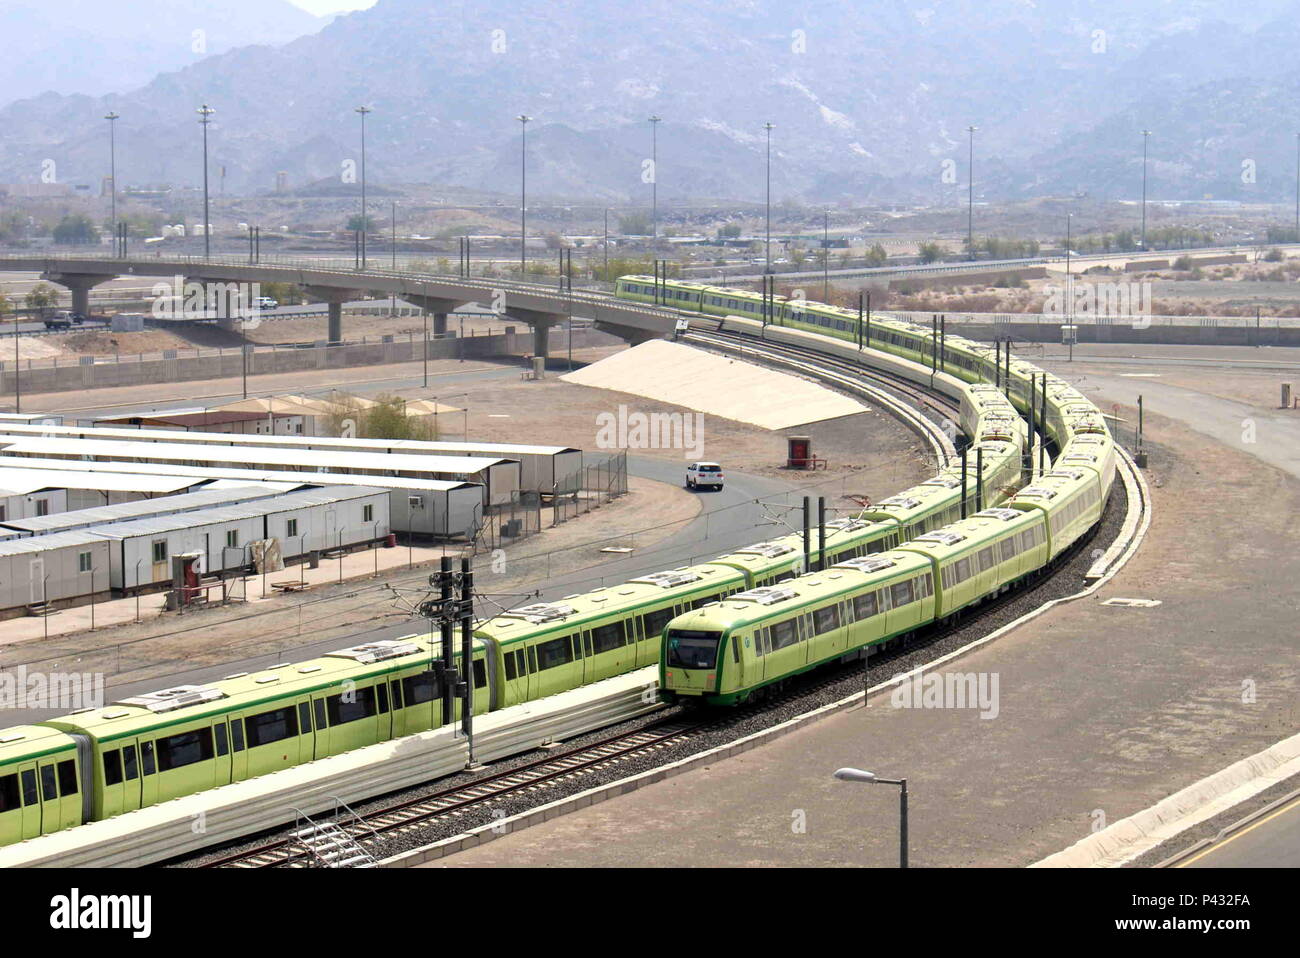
[431,389,1300,867]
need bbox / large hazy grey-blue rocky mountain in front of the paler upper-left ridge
[0,0,1300,204]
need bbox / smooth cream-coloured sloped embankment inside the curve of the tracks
[560,339,866,429]
